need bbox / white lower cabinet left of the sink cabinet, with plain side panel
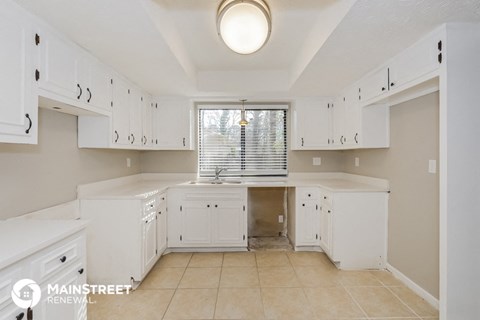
[80,195,160,285]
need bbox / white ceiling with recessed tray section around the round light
[13,0,480,99]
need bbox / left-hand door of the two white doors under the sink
[180,201,212,246]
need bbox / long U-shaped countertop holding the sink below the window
[79,173,389,200]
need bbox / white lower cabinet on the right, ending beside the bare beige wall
[320,190,388,269]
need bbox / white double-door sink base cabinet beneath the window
[168,187,247,248]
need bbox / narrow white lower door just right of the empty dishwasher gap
[296,201,320,246]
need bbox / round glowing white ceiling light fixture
[217,0,272,54]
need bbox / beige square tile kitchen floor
[88,252,438,320]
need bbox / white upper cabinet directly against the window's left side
[154,98,195,150]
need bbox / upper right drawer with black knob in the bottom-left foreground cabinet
[31,235,85,283]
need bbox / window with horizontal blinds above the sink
[198,105,288,177]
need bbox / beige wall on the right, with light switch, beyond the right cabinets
[344,93,439,298]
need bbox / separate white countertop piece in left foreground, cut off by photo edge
[0,219,88,270]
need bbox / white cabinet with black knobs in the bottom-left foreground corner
[0,230,87,320]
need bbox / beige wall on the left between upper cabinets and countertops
[0,109,140,220]
